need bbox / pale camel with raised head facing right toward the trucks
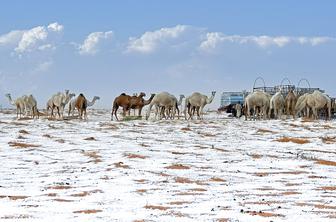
[184,91,216,119]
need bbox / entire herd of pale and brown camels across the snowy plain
[6,90,332,120]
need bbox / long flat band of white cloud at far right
[199,32,336,52]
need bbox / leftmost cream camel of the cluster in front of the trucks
[244,91,270,120]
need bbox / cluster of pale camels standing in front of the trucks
[243,90,332,120]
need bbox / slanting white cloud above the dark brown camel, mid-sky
[127,25,189,53]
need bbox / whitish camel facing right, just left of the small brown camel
[47,90,75,118]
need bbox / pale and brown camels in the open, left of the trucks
[2,90,216,120]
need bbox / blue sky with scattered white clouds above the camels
[0,0,336,108]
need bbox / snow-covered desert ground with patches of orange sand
[0,110,336,222]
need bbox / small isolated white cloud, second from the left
[78,31,113,55]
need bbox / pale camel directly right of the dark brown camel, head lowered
[146,92,177,120]
